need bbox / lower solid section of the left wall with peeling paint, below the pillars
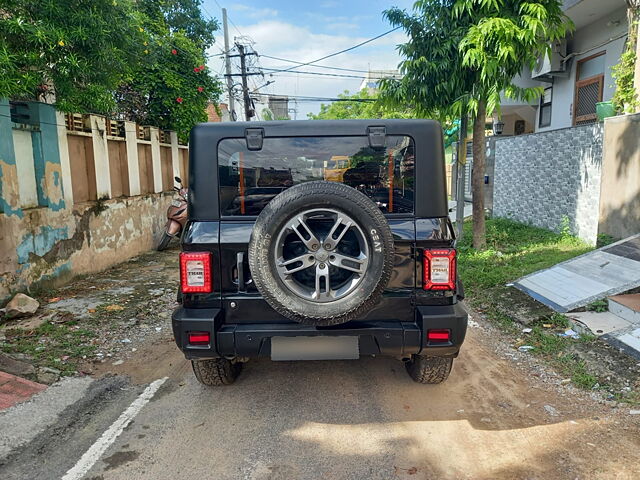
[0,193,173,301]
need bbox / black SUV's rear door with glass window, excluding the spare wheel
[218,135,416,323]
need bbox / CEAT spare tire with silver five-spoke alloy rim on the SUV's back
[249,181,394,326]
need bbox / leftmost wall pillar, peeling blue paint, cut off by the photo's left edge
[0,98,22,217]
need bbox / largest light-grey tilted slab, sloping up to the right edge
[513,234,640,313]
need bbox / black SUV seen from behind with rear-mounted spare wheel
[172,120,467,385]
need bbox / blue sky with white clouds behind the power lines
[203,0,414,120]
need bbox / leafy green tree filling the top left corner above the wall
[0,0,143,113]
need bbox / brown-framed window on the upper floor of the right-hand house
[573,52,605,125]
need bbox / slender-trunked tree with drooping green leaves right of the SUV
[383,0,572,248]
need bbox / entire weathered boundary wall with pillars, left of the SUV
[0,99,187,303]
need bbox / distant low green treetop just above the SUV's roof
[307,90,416,120]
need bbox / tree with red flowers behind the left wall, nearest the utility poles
[116,0,222,139]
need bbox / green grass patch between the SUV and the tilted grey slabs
[458,218,598,389]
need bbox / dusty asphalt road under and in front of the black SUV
[0,328,640,480]
